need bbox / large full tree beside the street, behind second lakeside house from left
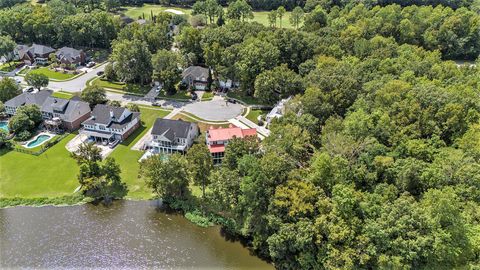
[110,40,152,84]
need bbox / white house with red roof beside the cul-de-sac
[206,125,257,164]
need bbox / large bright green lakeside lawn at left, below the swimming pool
[0,134,78,198]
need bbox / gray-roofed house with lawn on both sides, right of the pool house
[80,104,140,142]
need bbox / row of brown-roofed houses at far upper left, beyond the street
[3,43,87,65]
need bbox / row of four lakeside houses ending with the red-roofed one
[5,90,257,164]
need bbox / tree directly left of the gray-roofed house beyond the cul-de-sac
[152,50,182,95]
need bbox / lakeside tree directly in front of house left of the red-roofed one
[139,154,189,202]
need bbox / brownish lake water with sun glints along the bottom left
[0,201,273,269]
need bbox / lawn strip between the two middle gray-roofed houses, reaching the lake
[110,107,169,199]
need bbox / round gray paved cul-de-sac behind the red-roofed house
[183,96,243,121]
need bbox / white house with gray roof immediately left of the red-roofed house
[145,118,199,154]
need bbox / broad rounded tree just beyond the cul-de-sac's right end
[254,64,304,105]
